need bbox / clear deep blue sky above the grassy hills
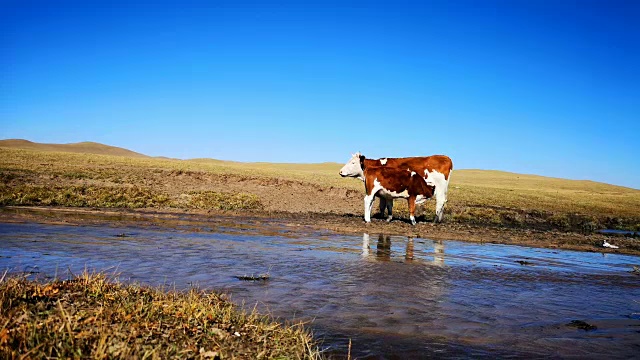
[0,0,640,188]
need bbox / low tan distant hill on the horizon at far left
[0,139,148,158]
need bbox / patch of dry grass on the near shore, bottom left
[0,273,320,359]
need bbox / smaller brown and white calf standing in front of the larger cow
[340,155,434,225]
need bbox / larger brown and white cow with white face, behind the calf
[340,153,453,222]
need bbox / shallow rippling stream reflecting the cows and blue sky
[0,219,640,359]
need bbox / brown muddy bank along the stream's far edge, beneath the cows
[0,206,640,255]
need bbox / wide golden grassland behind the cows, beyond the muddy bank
[0,147,640,232]
